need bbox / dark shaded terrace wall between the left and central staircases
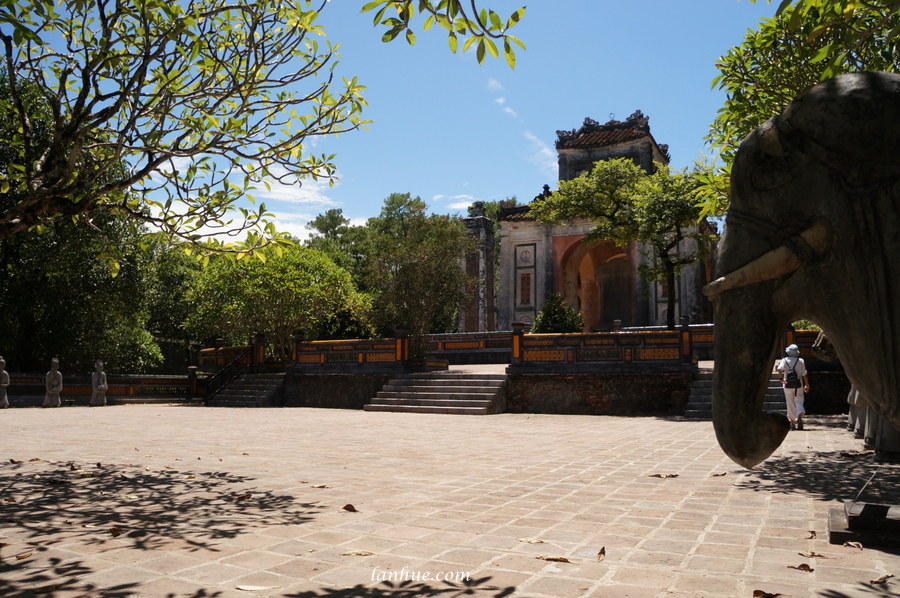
[278,372,396,409]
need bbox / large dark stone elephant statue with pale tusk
[704,72,900,467]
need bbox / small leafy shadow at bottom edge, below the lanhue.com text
[284,576,516,598]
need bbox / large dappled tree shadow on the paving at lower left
[0,459,324,598]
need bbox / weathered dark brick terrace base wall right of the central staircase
[506,372,694,415]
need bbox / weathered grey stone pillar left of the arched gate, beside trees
[459,201,497,332]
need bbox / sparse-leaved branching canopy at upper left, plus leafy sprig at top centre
[0,0,522,249]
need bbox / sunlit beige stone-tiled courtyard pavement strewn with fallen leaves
[0,406,900,598]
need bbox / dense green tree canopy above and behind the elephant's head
[699,0,900,216]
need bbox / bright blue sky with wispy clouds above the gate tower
[256,0,775,236]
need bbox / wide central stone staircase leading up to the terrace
[363,371,506,415]
